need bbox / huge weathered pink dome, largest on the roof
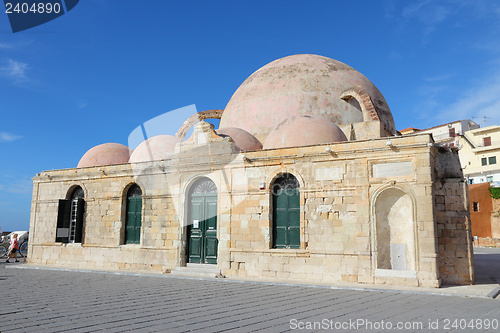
[220,54,396,142]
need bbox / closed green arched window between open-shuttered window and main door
[125,184,142,244]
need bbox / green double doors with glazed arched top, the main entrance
[187,178,218,264]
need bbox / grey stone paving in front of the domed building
[0,264,500,333]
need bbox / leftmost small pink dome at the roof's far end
[77,142,133,168]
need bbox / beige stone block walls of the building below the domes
[30,128,473,287]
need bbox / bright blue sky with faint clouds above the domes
[0,0,500,230]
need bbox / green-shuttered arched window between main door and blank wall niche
[271,173,300,249]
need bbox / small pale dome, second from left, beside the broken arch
[130,135,182,163]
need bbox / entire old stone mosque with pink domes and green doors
[29,54,474,287]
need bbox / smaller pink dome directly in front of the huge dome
[264,114,347,149]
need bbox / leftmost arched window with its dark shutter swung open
[56,186,85,243]
